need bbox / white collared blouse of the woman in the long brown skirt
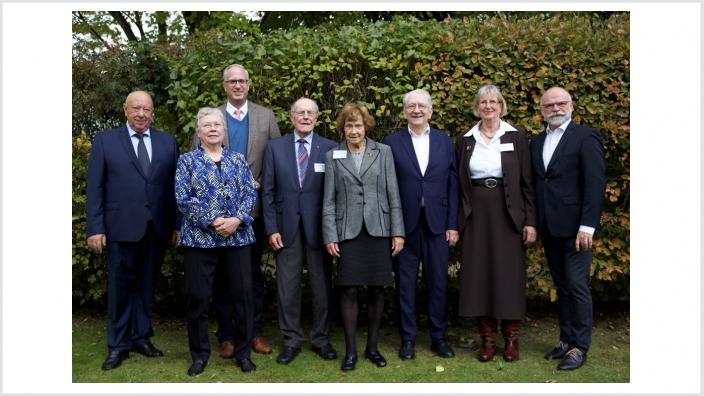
[465,121,516,179]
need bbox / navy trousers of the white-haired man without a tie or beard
[396,210,449,341]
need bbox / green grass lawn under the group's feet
[72,312,630,383]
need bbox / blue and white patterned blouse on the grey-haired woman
[176,147,257,248]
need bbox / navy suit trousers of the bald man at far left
[106,221,166,351]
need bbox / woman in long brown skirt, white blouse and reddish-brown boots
[456,85,537,362]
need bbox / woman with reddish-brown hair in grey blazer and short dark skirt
[323,103,404,371]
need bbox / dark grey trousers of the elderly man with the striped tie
[276,225,331,348]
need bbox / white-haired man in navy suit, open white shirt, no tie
[384,89,459,360]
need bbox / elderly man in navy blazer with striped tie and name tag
[262,98,337,364]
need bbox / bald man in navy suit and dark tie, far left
[86,91,180,370]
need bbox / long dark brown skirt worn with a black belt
[459,184,526,320]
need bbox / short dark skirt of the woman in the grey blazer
[337,225,393,286]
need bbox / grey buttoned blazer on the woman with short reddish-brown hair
[323,138,405,244]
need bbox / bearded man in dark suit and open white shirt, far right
[530,87,606,370]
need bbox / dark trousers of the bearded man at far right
[540,227,593,352]
